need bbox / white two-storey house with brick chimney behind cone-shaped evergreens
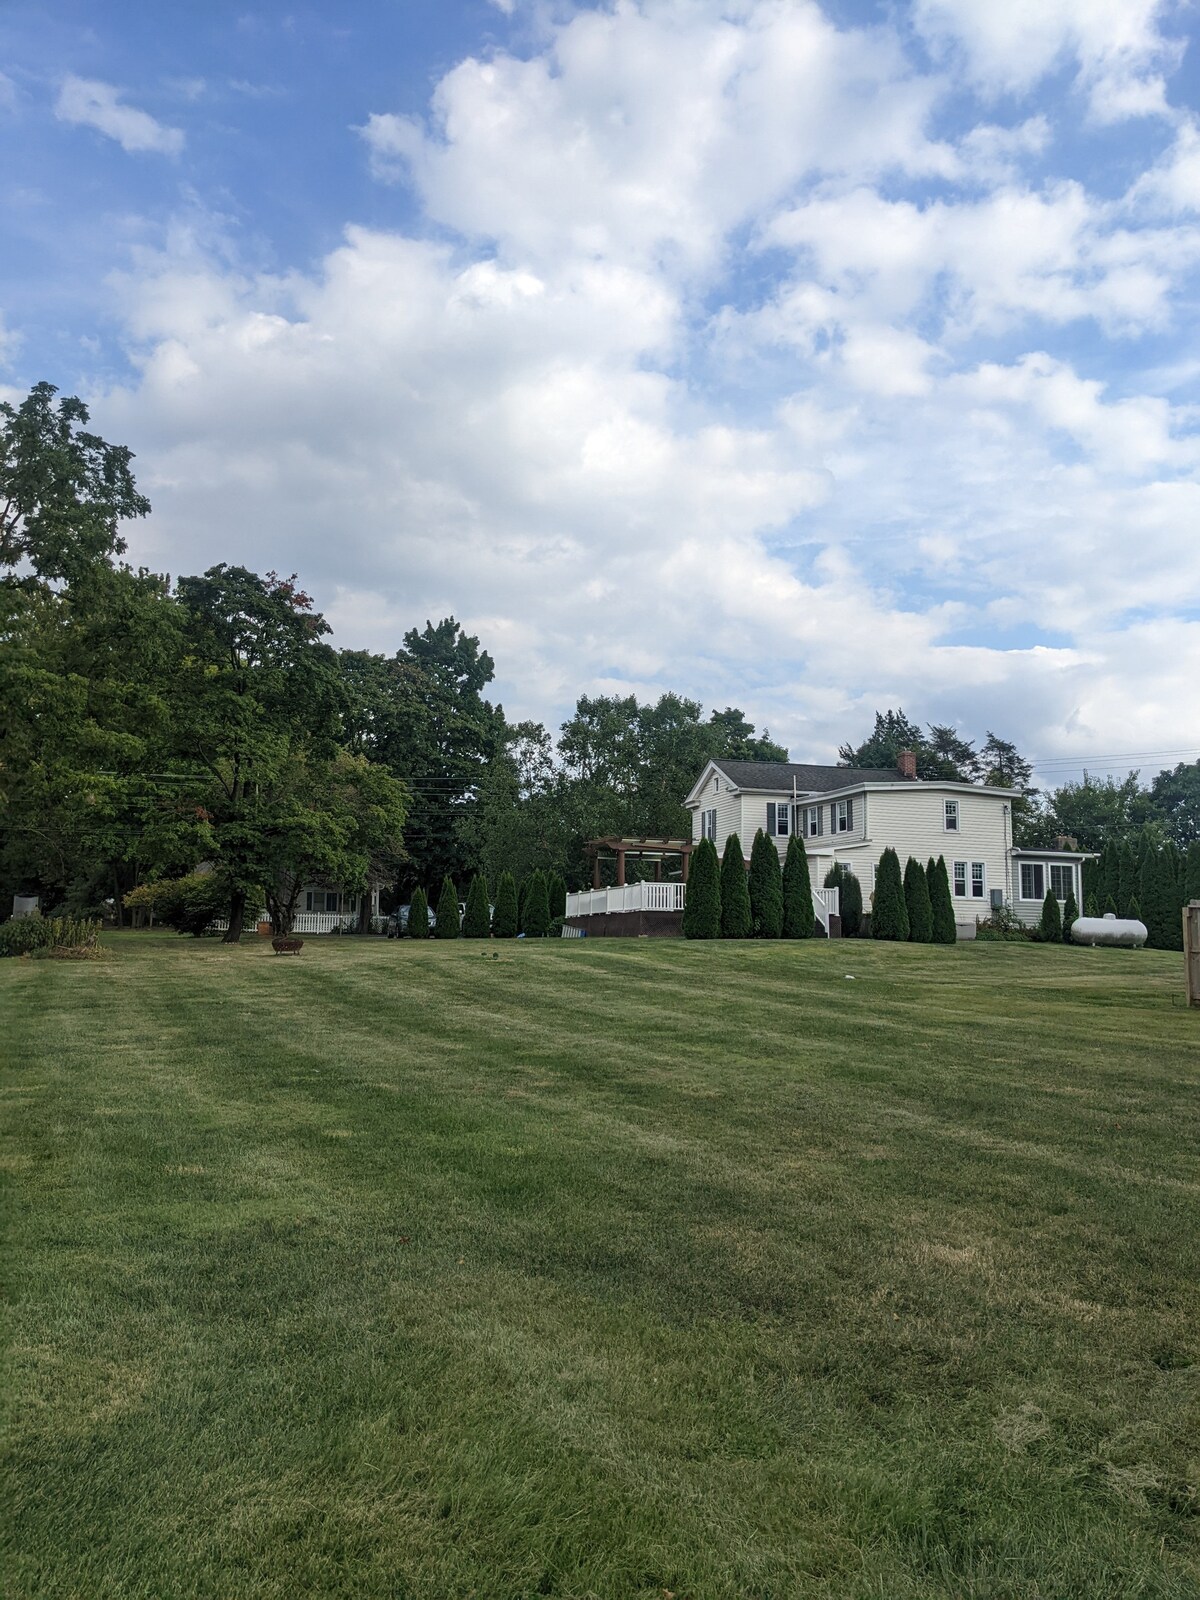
[683,750,1086,938]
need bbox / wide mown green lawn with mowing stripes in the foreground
[0,934,1200,1600]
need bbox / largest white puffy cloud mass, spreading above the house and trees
[89,0,1200,757]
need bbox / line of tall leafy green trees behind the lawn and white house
[0,384,1200,939]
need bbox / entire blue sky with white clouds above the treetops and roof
[0,0,1200,778]
